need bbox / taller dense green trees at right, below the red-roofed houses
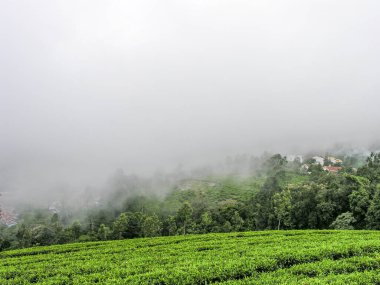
[252,153,380,229]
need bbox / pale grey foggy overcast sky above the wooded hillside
[0,0,380,191]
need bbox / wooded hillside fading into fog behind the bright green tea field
[0,153,380,250]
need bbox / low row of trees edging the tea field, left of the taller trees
[0,197,249,249]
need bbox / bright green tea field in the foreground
[0,231,380,284]
